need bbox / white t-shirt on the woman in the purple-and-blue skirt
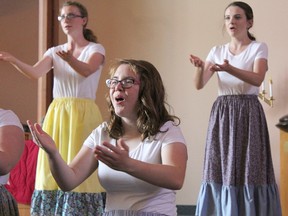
[206,41,268,95]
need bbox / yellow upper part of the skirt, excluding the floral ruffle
[35,98,104,193]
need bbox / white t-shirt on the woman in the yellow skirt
[44,42,105,100]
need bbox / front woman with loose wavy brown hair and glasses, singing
[28,59,187,216]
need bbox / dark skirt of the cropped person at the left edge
[0,185,19,216]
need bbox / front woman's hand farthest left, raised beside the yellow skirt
[27,120,58,155]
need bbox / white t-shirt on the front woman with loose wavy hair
[84,121,186,216]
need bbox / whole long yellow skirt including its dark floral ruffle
[30,98,105,216]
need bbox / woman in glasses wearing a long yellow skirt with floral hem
[0,1,105,216]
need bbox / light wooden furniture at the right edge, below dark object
[280,130,288,216]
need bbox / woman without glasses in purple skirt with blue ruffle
[190,1,281,216]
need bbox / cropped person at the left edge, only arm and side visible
[0,108,25,216]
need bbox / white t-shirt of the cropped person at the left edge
[0,109,23,184]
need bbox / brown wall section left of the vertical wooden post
[0,0,38,122]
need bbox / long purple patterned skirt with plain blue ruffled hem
[196,95,281,216]
